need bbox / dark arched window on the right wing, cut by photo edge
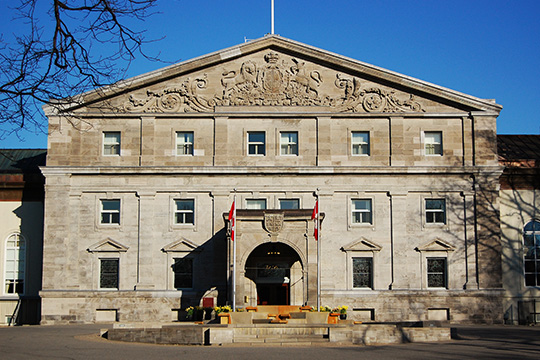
[523,221,540,286]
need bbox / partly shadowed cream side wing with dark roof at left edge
[0,149,46,325]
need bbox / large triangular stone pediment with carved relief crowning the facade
[46,35,501,114]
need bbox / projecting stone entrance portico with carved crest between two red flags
[224,209,317,307]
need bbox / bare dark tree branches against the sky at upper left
[0,0,157,139]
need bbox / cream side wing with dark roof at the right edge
[497,135,540,324]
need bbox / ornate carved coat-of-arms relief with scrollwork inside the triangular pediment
[118,51,424,113]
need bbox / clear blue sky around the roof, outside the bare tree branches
[0,0,540,148]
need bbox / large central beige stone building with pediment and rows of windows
[40,35,503,324]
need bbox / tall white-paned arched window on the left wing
[4,233,26,295]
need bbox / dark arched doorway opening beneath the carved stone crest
[245,242,303,305]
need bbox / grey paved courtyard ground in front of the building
[0,325,540,360]
